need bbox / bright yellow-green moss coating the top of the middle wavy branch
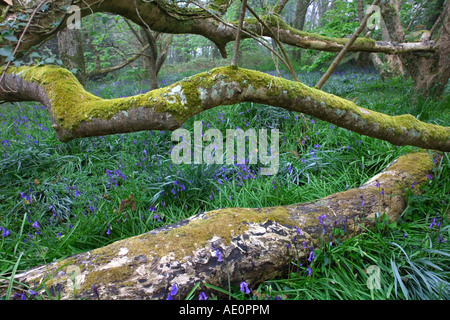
[8,66,450,148]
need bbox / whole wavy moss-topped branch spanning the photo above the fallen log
[0,66,450,151]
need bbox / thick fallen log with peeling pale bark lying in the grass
[0,153,432,300]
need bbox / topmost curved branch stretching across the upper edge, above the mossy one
[0,0,435,64]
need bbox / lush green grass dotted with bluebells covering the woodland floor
[0,64,450,299]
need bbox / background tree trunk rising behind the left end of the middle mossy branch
[58,28,87,86]
